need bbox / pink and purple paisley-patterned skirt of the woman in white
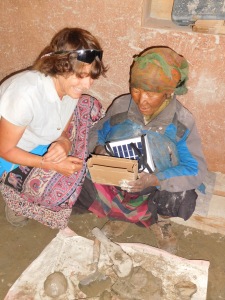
[0,95,101,229]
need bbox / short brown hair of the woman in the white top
[32,28,108,79]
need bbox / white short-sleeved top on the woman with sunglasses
[0,71,78,151]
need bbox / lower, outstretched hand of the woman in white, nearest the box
[53,156,83,176]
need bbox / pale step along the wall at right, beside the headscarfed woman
[171,172,225,235]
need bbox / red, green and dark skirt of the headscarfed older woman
[77,176,198,227]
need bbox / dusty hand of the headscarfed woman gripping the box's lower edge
[121,172,160,193]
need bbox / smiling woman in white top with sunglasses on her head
[0,28,107,229]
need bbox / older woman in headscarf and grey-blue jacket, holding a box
[77,47,207,252]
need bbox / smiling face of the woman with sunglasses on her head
[54,64,94,99]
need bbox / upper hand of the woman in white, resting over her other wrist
[44,139,71,164]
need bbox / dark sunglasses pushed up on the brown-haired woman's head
[42,49,103,64]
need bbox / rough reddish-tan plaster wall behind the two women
[0,0,225,173]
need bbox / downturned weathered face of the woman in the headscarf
[131,88,167,116]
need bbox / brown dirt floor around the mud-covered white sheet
[0,195,225,300]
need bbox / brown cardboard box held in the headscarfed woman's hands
[87,155,138,186]
